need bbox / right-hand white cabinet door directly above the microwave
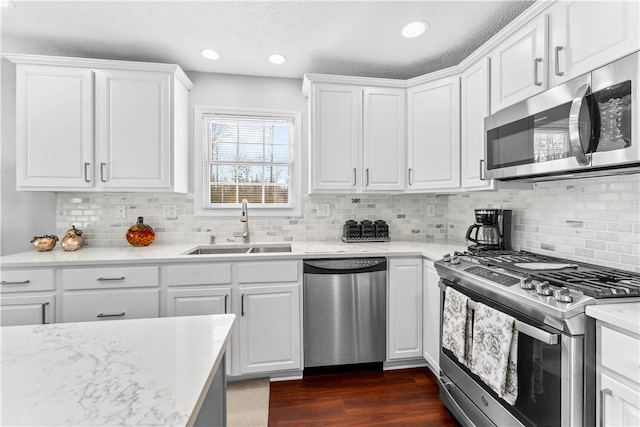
[549,1,640,85]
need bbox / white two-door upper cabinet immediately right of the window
[305,75,406,193]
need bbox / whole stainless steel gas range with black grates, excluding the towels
[435,251,640,427]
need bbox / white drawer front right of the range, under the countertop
[600,327,640,383]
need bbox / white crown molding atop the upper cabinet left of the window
[3,53,193,90]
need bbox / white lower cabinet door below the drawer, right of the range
[598,374,640,427]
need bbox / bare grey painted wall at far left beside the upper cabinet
[0,58,56,255]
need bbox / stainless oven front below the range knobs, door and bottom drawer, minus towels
[440,281,584,426]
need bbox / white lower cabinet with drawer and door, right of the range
[596,321,640,427]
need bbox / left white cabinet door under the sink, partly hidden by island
[167,288,231,316]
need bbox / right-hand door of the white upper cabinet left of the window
[96,70,172,190]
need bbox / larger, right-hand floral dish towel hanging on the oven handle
[470,303,518,405]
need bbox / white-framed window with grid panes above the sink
[195,107,300,215]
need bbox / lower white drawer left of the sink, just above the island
[62,289,160,322]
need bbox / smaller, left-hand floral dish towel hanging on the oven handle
[442,286,472,366]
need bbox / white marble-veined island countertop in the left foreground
[0,314,235,426]
